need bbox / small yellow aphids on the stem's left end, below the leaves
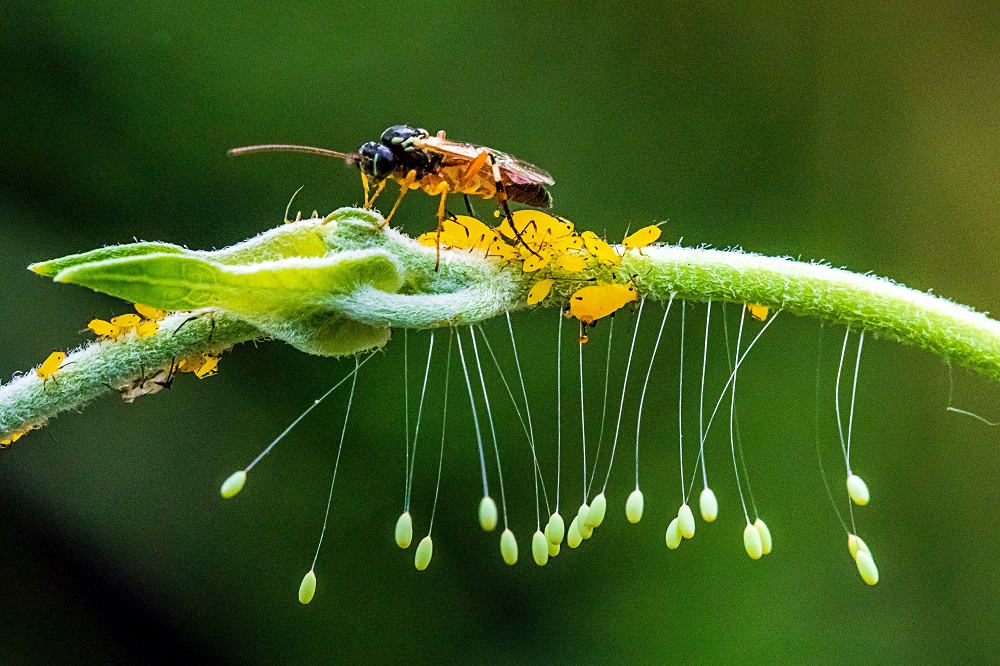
[0,303,219,449]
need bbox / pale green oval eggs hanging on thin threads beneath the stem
[220,296,878,604]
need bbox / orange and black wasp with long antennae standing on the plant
[229,125,555,270]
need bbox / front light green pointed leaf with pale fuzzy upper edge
[55,250,402,315]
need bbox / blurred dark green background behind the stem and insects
[0,1,1000,663]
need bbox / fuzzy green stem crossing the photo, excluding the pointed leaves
[0,209,1000,435]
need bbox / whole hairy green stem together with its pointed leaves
[0,209,1000,436]
